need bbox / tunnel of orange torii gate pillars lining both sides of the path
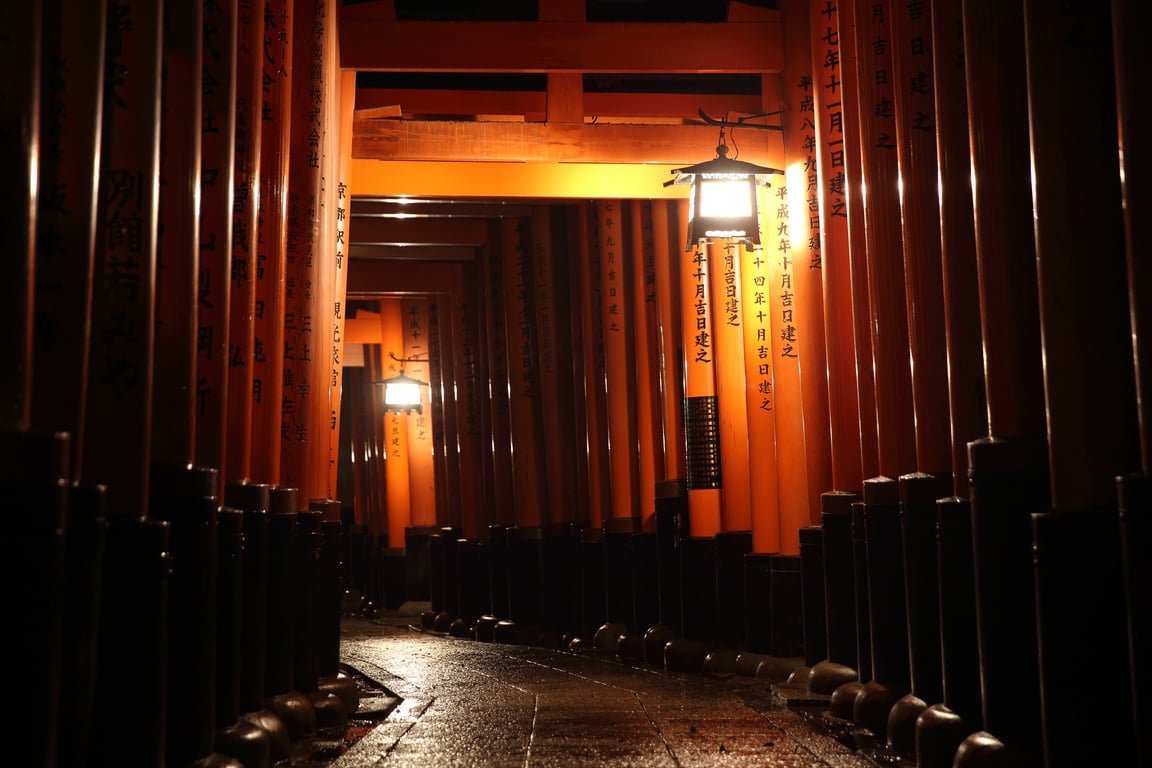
[0,0,1152,768]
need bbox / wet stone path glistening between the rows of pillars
[332,618,878,768]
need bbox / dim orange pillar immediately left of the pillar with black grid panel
[652,200,684,480]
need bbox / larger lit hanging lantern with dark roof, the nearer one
[664,113,783,251]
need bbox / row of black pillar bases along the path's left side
[0,433,358,768]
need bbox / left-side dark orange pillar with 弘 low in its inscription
[223,0,264,486]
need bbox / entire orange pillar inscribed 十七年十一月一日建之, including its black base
[809,3,874,681]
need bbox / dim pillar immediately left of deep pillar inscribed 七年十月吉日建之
[577,206,612,529]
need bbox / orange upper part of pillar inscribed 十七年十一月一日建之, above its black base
[810,3,863,491]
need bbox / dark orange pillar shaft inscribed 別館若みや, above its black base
[81,2,162,520]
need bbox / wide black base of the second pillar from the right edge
[1032,508,1138,768]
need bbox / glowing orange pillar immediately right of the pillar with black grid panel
[708,239,752,532]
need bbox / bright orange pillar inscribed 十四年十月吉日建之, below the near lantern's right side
[740,242,780,554]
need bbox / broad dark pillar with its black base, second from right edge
[1024,0,1142,768]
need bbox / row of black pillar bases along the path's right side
[343,439,1152,768]
